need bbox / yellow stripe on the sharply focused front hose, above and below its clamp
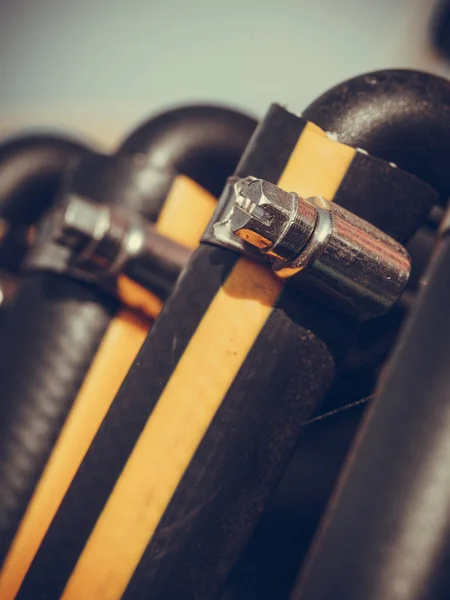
[62,125,355,600]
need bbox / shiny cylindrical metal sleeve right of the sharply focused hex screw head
[273,197,411,319]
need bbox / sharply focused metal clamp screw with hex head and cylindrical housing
[209,177,411,319]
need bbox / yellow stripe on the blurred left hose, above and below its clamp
[0,175,216,600]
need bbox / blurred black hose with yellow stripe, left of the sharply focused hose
[0,109,252,598]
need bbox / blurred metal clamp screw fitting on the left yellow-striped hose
[26,195,191,317]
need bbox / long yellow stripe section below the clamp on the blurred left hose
[0,311,147,600]
